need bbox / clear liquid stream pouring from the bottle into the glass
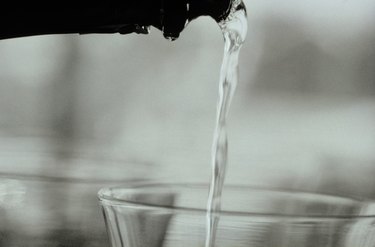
[205,0,247,247]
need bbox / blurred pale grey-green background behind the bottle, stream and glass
[0,0,375,246]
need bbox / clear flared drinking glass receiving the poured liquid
[98,184,375,247]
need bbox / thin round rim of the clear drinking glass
[97,181,375,220]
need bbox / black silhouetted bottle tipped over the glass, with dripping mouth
[0,0,231,40]
